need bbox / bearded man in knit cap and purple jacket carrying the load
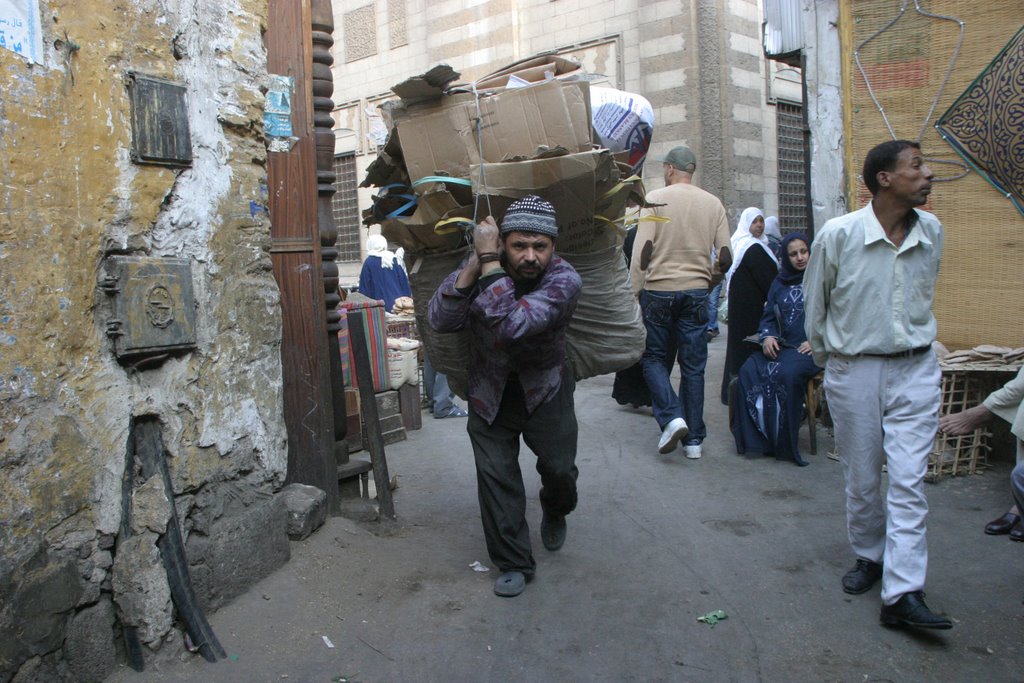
[428,196,582,597]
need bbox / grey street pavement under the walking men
[109,335,1024,683]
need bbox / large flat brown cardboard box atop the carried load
[396,81,593,182]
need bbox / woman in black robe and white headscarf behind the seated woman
[722,207,778,405]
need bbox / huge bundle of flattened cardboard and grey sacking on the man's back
[362,54,644,396]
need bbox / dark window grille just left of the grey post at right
[775,101,810,232]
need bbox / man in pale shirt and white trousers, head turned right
[804,140,952,629]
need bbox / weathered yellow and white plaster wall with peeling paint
[0,0,287,681]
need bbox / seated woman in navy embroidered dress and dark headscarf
[730,233,821,467]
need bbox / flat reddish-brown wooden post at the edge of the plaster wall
[264,0,339,513]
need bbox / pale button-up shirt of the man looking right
[804,204,943,367]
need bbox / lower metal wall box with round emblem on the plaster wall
[100,256,196,362]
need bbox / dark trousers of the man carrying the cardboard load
[466,369,579,578]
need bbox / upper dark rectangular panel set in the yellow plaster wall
[128,72,191,166]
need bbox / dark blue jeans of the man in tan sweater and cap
[640,290,708,445]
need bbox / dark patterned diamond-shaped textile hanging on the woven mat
[935,28,1024,214]
